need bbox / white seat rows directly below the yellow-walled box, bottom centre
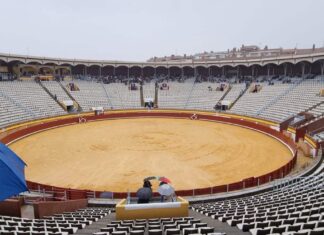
[94,217,224,235]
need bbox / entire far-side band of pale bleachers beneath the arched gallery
[0,76,324,132]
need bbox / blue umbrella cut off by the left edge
[0,142,28,201]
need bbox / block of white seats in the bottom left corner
[0,208,110,235]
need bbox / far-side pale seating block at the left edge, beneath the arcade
[0,81,66,127]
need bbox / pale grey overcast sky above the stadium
[0,0,324,61]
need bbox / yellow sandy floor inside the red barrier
[10,118,292,191]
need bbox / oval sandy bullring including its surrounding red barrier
[5,110,296,198]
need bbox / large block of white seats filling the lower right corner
[193,173,324,235]
